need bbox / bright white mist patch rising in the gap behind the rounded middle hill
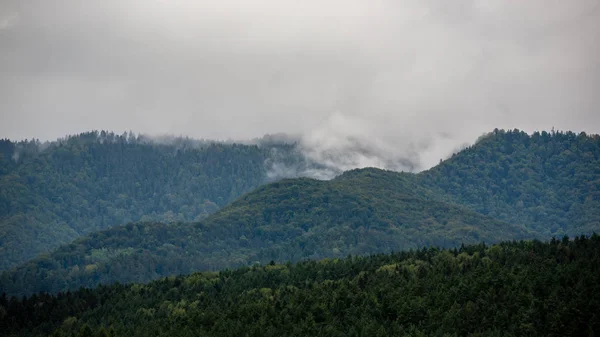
[299,113,457,174]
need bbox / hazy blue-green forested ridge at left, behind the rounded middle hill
[0,132,304,270]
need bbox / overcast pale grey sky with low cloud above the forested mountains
[0,0,600,171]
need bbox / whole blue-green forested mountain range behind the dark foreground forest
[0,130,600,294]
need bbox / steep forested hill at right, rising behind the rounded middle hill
[418,130,600,236]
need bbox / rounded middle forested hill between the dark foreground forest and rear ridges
[0,169,534,294]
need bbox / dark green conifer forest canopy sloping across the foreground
[0,235,600,337]
